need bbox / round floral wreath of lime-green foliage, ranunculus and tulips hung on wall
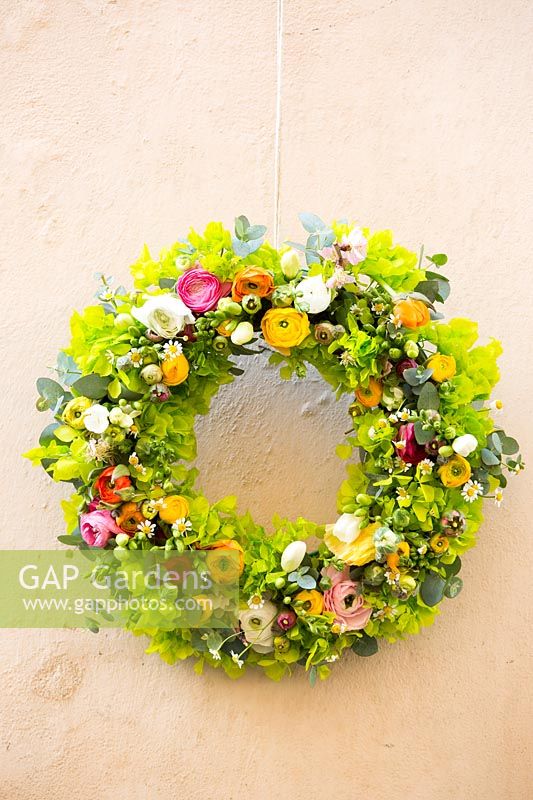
[27,214,523,683]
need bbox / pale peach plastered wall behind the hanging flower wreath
[0,0,533,800]
